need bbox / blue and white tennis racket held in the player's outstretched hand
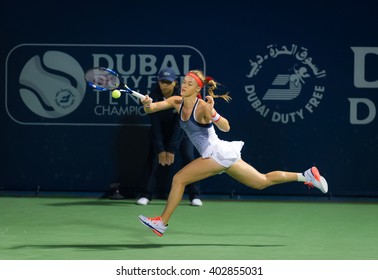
[84,67,145,99]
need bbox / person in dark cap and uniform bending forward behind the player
[137,68,202,206]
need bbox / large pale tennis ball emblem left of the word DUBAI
[19,51,86,118]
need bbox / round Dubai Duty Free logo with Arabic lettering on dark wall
[244,44,326,124]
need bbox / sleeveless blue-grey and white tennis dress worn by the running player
[180,99,244,168]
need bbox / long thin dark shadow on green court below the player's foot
[9,243,286,250]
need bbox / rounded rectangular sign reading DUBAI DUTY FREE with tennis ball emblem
[5,44,206,126]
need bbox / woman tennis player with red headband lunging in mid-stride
[139,70,328,236]
